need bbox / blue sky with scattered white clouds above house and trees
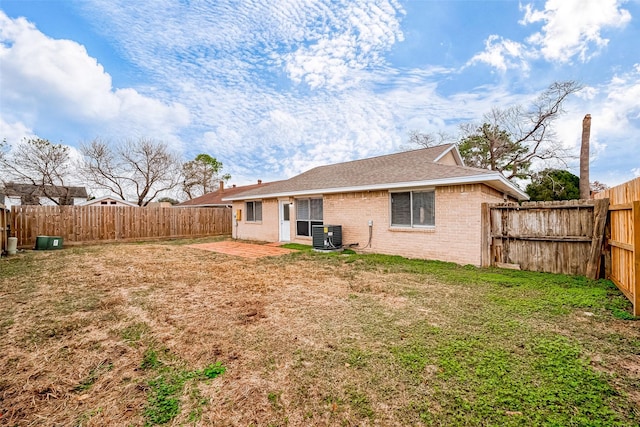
[0,0,640,191]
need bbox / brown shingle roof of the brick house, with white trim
[223,144,529,201]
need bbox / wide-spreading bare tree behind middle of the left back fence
[80,139,180,206]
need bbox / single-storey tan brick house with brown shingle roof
[223,144,528,265]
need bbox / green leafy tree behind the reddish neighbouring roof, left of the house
[182,154,231,199]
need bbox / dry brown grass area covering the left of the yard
[0,244,456,425]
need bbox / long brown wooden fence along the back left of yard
[11,206,231,248]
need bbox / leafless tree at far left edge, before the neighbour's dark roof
[0,138,71,204]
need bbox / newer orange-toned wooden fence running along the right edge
[595,178,640,316]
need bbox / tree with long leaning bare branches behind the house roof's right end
[459,81,581,179]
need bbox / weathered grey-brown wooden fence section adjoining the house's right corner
[482,199,608,278]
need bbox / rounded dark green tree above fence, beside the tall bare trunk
[526,169,580,201]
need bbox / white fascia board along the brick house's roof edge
[222,173,529,201]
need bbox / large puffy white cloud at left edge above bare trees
[0,11,189,145]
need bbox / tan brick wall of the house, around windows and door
[233,184,503,265]
